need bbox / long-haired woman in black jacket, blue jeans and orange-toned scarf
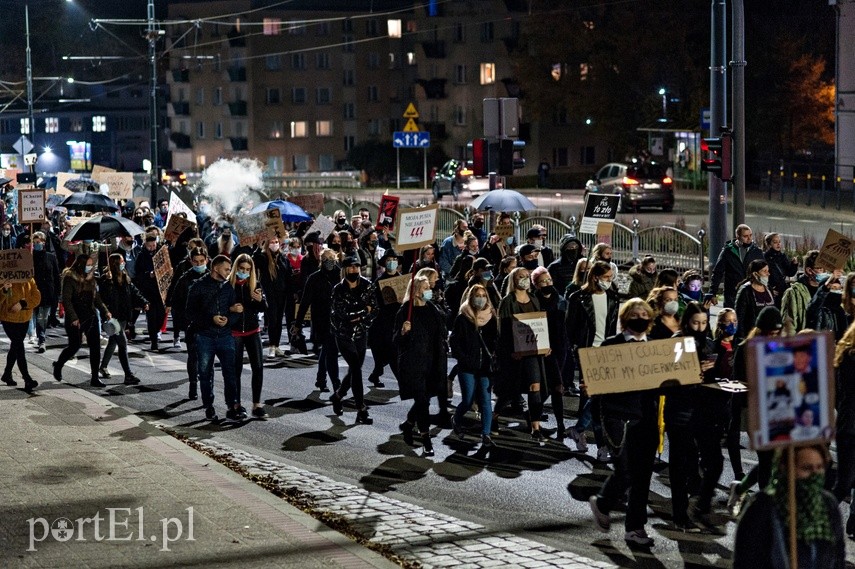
[448,284,499,448]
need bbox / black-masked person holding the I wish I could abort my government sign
[589,300,664,547]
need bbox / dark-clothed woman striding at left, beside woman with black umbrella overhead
[53,255,113,387]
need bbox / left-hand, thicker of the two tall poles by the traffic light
[708,0,727,263]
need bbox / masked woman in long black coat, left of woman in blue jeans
[393,277,448,456]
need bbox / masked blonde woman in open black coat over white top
[564,261,618,462]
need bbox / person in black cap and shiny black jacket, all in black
[330,256,377,425]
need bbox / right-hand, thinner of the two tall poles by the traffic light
[730,0,746,228]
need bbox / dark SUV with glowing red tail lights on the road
[585,161,674,212]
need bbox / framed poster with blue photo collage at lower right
[747,332,835,450]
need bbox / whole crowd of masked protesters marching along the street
[0,194,855,567]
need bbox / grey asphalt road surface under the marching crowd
[18,330,768,568]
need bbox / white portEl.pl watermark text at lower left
[27,506,196,551]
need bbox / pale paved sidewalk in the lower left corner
[0,366,398,568]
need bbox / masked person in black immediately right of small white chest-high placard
[531,267,567,441]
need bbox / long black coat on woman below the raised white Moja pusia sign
[392,302,448,400]
